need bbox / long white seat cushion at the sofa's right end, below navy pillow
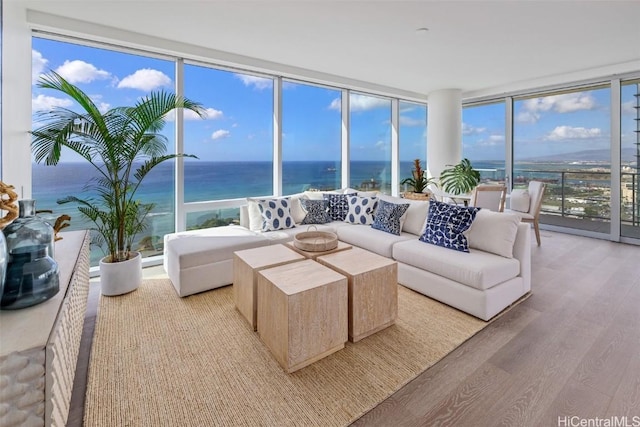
[393,239,520,290]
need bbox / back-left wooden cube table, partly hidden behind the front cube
[233,244,305,331]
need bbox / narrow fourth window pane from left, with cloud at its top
[348,92,391,194]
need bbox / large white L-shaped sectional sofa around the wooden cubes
[164,193,531,320]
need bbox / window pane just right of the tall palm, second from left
[184,64,274,229]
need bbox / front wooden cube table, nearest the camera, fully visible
[258,260,347,373]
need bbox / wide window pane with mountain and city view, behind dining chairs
[513,86,611,233]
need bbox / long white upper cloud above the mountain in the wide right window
[516,92,596,123]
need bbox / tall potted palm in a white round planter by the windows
[31,71,205,295]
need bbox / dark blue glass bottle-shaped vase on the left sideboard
[0,200,60,310]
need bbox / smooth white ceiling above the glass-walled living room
[25,0,640,97]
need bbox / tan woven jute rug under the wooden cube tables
[84,279,487,427]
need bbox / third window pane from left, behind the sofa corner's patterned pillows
[282,81,342,194]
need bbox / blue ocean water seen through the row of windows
[33,161,608,261]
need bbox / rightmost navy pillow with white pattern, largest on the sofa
[419,200,479,252]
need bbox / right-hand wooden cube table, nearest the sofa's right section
[317,247,398,342]
